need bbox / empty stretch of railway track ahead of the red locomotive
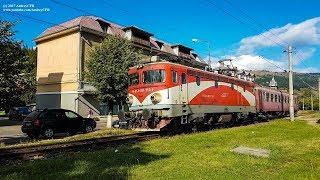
[0,133,160,164]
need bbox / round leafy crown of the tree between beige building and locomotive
[85,36,141,111]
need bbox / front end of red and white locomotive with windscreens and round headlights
[118,63,172,131]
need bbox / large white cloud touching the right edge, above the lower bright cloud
[238,17,320,54]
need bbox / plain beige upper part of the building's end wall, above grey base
[37,32,79,93]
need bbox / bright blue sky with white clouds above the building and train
[0,0,320,72]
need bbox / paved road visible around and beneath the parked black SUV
[0,117,111,145]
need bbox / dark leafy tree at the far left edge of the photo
[0,20,26,110]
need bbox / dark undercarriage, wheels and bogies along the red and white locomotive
[119,105,286,132]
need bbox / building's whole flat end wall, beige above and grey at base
[36,32,80,110]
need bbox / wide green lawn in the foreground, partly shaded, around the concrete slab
[0,120,320,179]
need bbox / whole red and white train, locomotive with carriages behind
[118,61,298,131]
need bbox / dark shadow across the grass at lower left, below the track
[0,146,170,179]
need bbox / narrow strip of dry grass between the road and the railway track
[0,128,136,150]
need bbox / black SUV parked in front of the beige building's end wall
[21,109,96,138]
